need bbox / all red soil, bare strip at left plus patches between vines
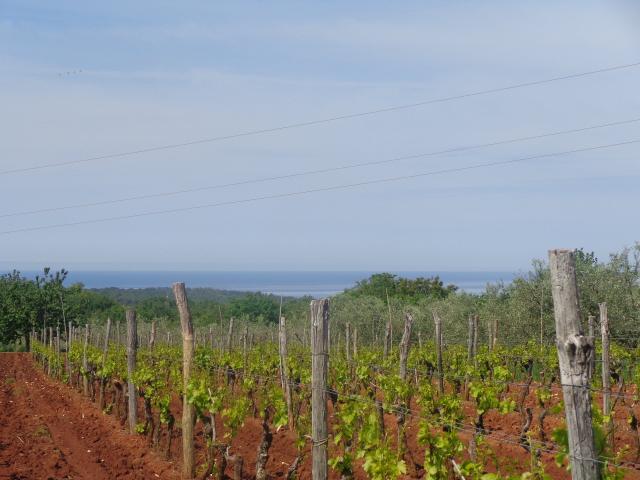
[0,353,640,480]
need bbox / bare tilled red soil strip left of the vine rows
[0,353,179,480]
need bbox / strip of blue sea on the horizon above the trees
[23,270,516,298]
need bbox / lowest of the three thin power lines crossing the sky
[0,139,640,235]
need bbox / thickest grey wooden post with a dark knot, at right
[549,250,600,480]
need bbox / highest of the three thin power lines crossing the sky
[5,62,640,175]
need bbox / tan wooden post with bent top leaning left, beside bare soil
[173,283,195,480]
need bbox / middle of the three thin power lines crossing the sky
[0,117,640,218]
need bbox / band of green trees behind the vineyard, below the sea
[0,243,640,344]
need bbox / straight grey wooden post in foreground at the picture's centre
[311,299,329,480]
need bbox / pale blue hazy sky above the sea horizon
[0,0,640,271]
